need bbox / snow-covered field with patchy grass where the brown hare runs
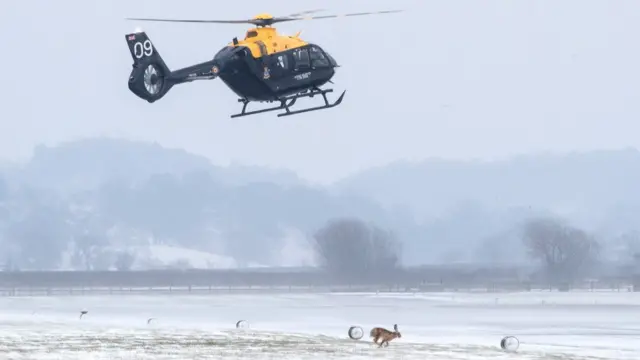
[0,292,640,360]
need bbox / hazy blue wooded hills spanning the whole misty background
[0,138,640,279]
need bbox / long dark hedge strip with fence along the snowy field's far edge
[0,267,640,296]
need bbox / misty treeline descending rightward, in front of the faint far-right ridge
[0,139,640,279]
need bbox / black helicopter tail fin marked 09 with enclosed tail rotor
[125,31,173,103]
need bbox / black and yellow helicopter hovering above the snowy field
[125,10,402,118]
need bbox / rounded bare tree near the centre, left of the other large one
[313,218,400,278]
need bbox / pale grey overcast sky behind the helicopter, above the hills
[0,0,640,182]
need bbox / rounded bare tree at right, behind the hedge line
[523,218,600,282]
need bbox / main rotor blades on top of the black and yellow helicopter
[126,9,404,27]
